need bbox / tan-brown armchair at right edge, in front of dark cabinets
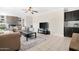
[69,33,79,51]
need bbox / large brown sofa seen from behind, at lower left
[0,32,21,51]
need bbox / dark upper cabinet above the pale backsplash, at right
[64,10,79,21]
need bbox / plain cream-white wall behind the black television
[33,8,64,36]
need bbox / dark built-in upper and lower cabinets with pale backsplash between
[64,10,79,37]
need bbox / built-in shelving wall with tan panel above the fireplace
[0,15,22,29]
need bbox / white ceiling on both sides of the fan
[0,7,64,16]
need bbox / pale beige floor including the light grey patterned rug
[20,34,71,51]
